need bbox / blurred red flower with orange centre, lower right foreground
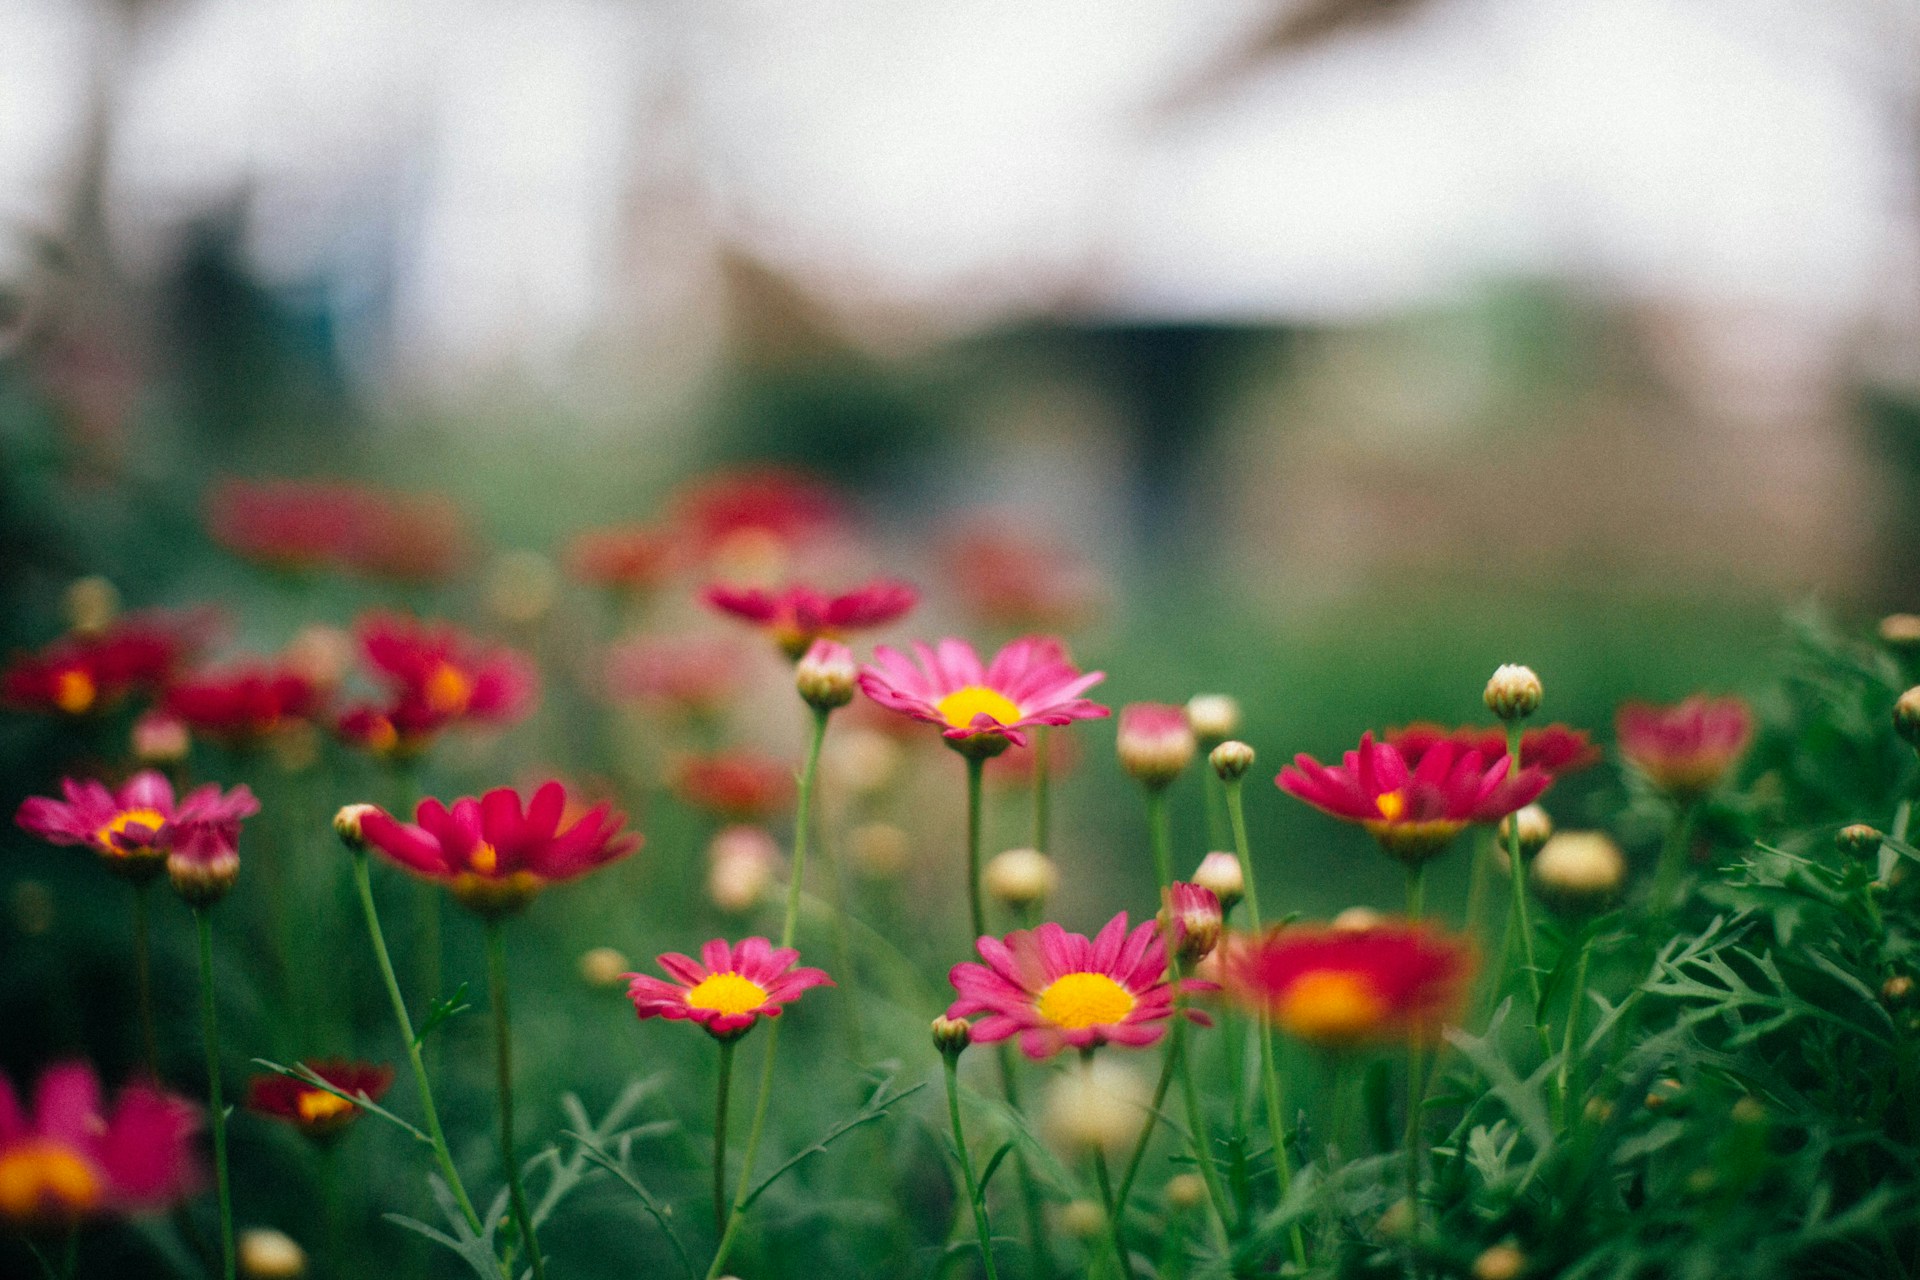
[1221,925,1473,1046]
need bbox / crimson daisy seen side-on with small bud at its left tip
[361,783,639,915]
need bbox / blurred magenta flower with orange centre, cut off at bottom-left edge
[0,1063,200,1230]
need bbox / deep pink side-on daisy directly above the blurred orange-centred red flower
[1273,733,1553,864]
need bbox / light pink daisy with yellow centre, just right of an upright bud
[860,635,1112,756]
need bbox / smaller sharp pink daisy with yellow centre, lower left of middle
[622,938,833,1040]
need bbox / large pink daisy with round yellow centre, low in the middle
[947,912,1212,1059]
